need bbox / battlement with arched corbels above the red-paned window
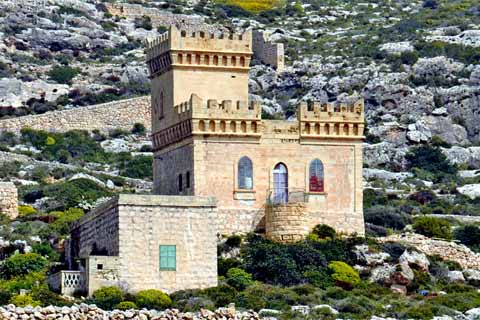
[297,100,365,138]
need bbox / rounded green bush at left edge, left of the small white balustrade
[0,253,47,279]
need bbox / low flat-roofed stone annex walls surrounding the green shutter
[69,194,218,292]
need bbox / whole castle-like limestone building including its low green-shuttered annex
[50,27,364,294]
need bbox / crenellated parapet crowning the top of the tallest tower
[146,26,252,61]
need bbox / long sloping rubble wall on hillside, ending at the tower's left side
[0,96,151,132]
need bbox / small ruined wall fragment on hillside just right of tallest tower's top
[252,31,285,72]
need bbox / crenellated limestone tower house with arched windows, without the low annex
[147,28,364,241]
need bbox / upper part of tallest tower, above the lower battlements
[147,26,253,133]
